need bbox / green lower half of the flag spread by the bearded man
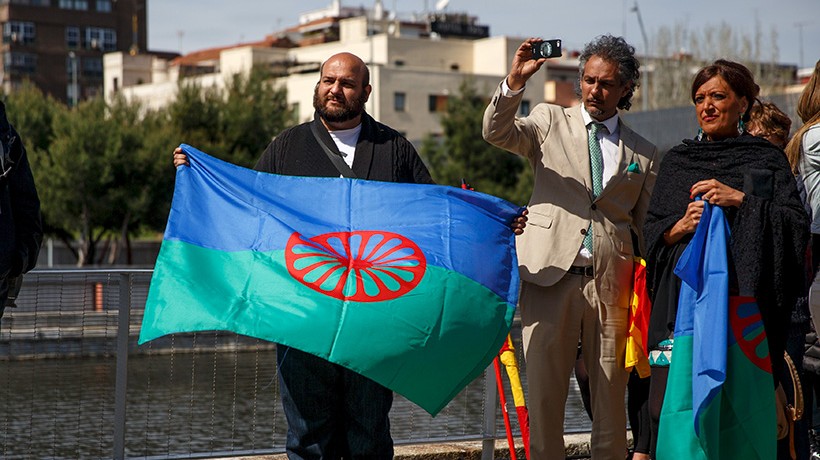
[140,241,514,414]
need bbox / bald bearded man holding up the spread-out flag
[174,53,432,460]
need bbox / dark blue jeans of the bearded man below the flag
[276,345,393,460]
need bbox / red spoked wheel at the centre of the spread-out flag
[285,231,427,302]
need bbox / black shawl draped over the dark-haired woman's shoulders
[644,135,809,370]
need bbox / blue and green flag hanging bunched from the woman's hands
[656,203,777,460]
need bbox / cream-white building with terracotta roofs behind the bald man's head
[104,5,578,142]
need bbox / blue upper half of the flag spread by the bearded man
[165,144,523,305]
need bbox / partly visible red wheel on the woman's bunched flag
[729,296,772,373]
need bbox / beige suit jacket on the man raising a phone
[483,85,660,306]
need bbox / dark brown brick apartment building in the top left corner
[0,0,147,104]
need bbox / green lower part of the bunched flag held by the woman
[656,335,777,460]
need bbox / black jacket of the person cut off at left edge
[0,102,43,315]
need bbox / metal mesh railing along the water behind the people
[0,270,588,459]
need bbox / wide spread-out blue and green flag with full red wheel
[140,145,521,415]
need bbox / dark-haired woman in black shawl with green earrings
[644,59,808,452]
